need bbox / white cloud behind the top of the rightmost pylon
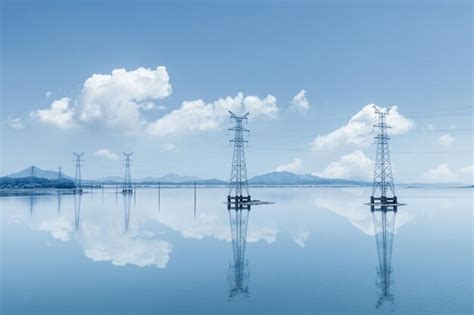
[312,104,414,151]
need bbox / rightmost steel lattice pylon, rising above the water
[370,106,397,204]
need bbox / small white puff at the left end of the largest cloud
[30,97,75,129]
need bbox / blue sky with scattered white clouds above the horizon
[0,0,473,183]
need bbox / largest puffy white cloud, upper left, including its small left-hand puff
[32,66,172,131]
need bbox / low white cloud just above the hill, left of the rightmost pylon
[313,150,374,179]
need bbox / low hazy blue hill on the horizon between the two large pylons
[249,172,370,186]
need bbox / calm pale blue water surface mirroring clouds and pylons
[0,188,473,314]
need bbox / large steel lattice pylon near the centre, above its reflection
[227,111,250,203]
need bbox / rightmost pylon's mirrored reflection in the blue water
[372,207,397,308]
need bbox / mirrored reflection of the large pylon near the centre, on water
[228,204,250,300]
